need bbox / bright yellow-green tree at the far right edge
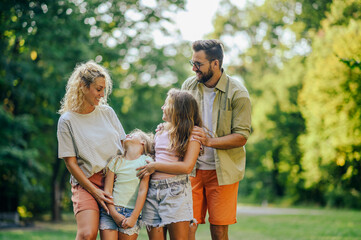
[299,0,361,208]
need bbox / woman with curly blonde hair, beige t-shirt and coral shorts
[57,61,125,239]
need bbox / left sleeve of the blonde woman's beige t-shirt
[57,118,77,158]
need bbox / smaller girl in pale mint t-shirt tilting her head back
[99,129,154,240]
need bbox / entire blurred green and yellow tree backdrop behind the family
[0,0,361,225]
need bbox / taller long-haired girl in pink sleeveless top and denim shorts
[137,89,202,240]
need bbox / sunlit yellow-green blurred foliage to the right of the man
[212,0,361,208]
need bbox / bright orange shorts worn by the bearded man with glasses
[190,169,239,225]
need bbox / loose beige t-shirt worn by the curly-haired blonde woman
[57,105,125,185]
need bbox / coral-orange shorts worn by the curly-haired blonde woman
[71,172,104,215]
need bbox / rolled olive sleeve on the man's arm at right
[231,95,251,139]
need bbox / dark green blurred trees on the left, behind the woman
[0,0,186,220]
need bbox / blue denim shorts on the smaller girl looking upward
[99,206,140,235]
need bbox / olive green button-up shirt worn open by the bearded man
[182,71,251,185]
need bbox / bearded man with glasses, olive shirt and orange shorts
[182,40,251,240]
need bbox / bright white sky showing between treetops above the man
[126,0,253,65]
